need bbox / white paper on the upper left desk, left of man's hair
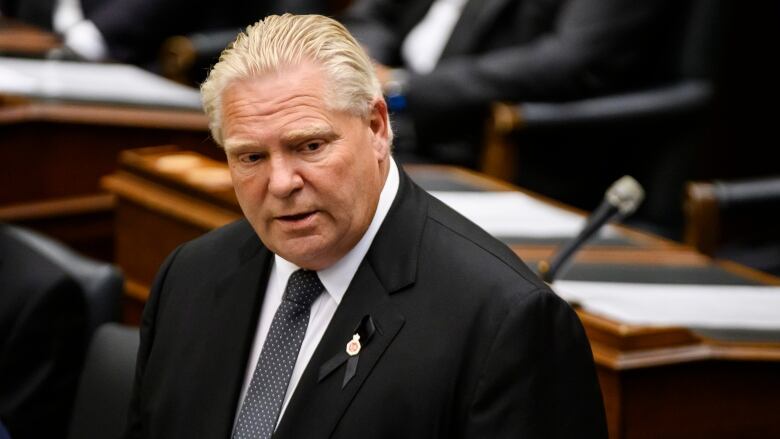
[0,57,201,110]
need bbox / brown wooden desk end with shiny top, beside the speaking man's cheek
[102,146,241,310]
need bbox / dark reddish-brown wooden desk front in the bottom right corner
[610,361,780,439]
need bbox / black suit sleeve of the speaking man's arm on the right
[464,290,607,438]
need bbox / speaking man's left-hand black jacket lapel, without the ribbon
[198,228,273,437]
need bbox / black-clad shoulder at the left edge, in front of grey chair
[0,224,87,439]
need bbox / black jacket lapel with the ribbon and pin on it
[274,171,427,439]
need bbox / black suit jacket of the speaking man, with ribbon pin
[128,168,606,439]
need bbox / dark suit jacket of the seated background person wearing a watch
[343,0,685,167]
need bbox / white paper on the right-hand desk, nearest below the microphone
[553,280,780,330]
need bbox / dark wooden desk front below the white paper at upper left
[0,103,216,205]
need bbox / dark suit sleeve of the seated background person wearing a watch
[407,0,670,120]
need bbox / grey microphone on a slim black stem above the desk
[538,175,645,283]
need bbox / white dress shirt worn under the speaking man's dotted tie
[234,158,399,425]
